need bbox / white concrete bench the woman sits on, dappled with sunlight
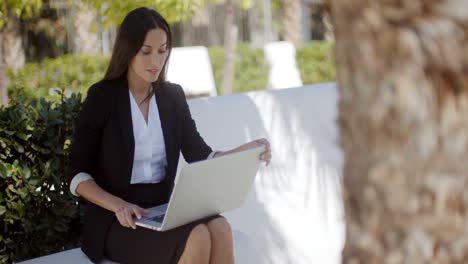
[20,83,344,264]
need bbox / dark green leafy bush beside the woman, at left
[0,94,81,263]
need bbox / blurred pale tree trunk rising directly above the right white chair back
[283,0,303,45]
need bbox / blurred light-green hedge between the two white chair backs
[209,44,268,94]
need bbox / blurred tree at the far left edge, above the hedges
[0,0,42,105]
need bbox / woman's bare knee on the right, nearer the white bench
[206,217,234,264]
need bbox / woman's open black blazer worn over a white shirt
[67,79,212,262]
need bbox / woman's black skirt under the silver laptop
[104,181,221,264]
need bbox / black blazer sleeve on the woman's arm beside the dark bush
[66,84,108,184]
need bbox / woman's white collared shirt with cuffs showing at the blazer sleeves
[70,90,219,196]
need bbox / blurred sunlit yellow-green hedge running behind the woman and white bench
[7,41,336,100]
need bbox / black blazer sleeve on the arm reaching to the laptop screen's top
[177,85,213,163]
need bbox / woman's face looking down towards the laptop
[129,28,168,84]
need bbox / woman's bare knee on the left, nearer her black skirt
[178,224,212,264]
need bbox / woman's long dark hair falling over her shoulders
[104,7,172,100]
